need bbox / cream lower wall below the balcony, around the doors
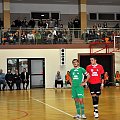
[0,49,120,88]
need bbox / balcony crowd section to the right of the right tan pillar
[83,22,120,42]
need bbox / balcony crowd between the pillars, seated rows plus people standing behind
[2,18,76,44]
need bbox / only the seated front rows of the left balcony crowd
[2,28,72,44]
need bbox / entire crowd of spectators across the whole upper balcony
[0,17,120,44]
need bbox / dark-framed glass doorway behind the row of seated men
[7,58,45,88]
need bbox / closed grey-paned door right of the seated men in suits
[30,59,45,88]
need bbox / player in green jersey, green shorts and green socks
[70,59,89,119]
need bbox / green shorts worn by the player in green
[72,86,84,99]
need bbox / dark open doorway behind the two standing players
[79,53,115,82]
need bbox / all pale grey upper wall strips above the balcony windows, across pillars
[0,3,120,14]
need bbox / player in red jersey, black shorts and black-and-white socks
[82,57,104,118]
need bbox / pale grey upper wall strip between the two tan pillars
[10,3,78,14]
